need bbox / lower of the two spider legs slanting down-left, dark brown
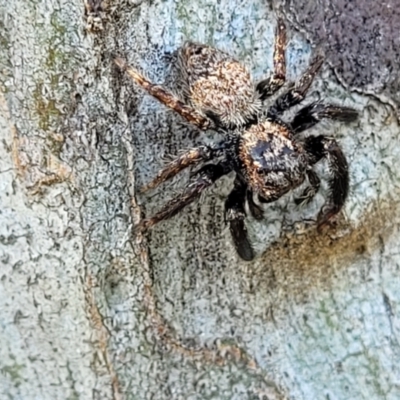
[138,162,232,231]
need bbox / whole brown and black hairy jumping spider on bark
[115,19,357,261]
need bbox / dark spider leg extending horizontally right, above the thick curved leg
[291,103,358,133]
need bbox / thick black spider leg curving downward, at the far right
[305,136,349,229]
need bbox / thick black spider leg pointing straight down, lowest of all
[225,177,255,261]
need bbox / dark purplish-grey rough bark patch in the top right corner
[282,0,400,118]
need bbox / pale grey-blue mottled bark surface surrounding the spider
[0,0,400,400]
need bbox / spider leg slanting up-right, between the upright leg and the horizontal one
[267,56,324,118]
